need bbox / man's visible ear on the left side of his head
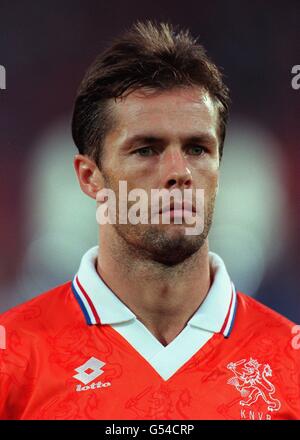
[74,154,104,199]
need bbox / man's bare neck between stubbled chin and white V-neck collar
[97,225,212,345]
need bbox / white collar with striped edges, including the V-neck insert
[72,246,237,381]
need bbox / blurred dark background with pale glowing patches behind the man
[0,0,300,323]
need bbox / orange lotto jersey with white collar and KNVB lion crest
[0,248,300,420]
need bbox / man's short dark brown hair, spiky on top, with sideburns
[72,20,229,165]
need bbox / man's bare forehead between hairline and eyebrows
[112,87,218,139]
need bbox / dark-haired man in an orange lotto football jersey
[0,22,300,419]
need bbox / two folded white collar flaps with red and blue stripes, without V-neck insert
[72,246,237,337]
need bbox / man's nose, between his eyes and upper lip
[162,148,192,189]
